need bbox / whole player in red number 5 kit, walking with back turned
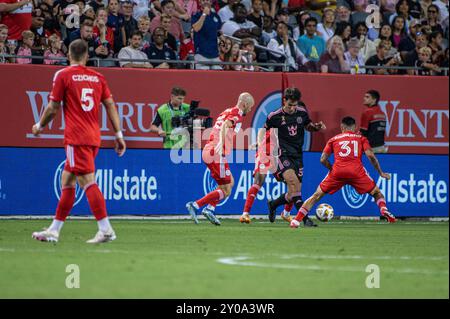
[32,40,126,243]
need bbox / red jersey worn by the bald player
[208,106,244,155]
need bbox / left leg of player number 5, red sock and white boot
[32,170,76,242]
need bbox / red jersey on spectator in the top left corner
[0,0,33,40]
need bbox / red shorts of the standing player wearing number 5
[64,145,98,176]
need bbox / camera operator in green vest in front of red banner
[150,87,190,148]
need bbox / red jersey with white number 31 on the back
[323,131,370,178]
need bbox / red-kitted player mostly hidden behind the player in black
[239,129,294,224]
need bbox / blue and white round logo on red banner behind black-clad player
[252,91,311,151]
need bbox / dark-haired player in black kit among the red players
[265,88,326,226]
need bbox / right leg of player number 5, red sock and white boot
[77,173,116,243]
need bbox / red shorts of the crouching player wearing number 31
[319,169,377,195]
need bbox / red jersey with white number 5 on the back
[50,65,111,147]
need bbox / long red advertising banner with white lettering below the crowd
[0,64,449,154]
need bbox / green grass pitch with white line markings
[0,219,449,298]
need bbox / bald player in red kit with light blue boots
[186,92,255,226]
